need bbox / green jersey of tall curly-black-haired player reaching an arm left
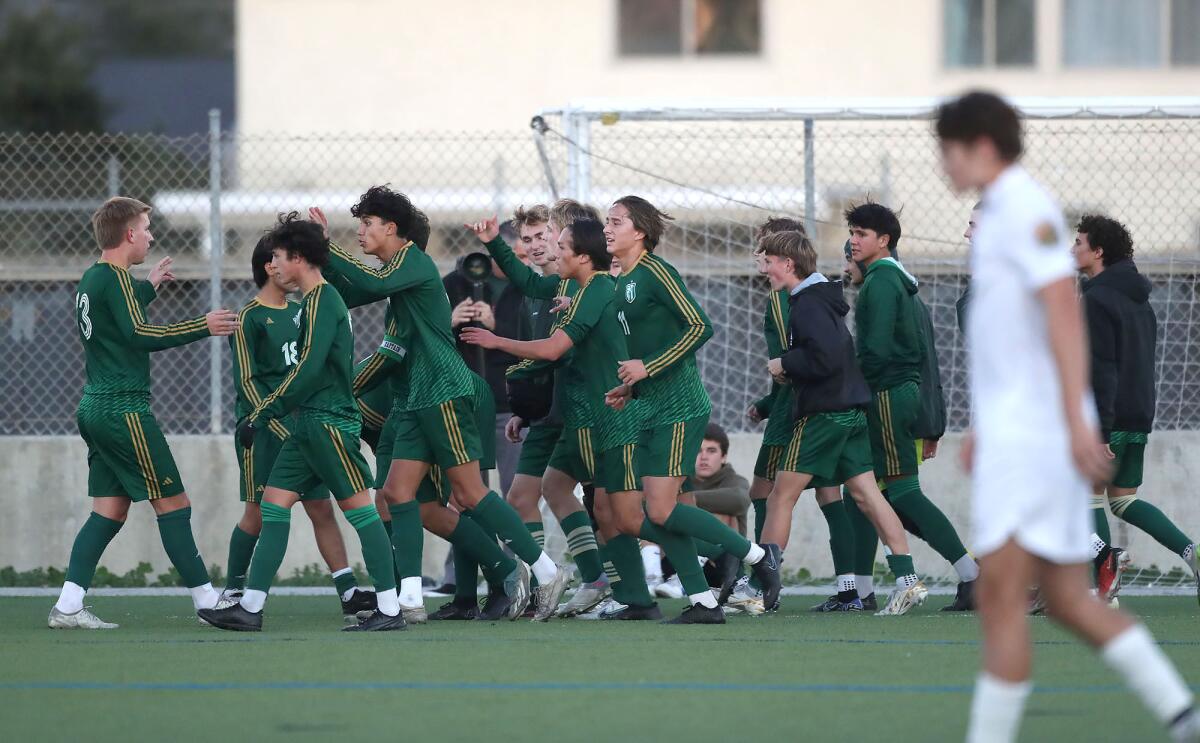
[326,242,474,411]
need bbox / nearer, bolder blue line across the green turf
[0,681,1200,694]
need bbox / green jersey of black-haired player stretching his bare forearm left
[562,271,646,451]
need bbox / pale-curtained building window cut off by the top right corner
[1062,0,1200,68]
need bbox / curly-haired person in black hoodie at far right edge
[1073,215,1200,599]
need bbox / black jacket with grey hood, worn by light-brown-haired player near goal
[781,281,871,418]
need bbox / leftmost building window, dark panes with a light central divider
[617,0,762,56]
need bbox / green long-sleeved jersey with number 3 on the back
[74,260,209,413]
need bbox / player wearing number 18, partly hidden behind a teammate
[222,238,376,617]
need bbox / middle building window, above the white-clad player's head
[942,0,1034,67]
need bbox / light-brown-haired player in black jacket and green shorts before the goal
[762,232,928,615]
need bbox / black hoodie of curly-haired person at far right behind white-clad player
[1084,259,1158,441]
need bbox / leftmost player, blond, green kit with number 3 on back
[48,197,238,629]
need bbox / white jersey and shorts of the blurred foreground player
[967,166,1092,563]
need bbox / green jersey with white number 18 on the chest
[229,298,300,438]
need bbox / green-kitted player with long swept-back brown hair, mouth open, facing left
[605,196,779,623]
